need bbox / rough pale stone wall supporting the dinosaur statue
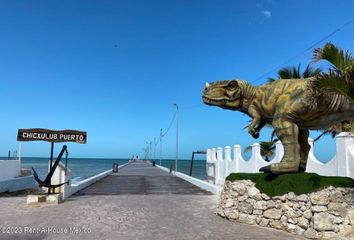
[216,180,354,239]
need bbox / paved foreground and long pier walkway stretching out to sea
[0,163,303,240]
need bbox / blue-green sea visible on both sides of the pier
[0,157,206,182]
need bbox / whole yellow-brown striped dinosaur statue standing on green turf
[203,78,354,173]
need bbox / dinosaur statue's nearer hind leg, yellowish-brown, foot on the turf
[260,118,300,173]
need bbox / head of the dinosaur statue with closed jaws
[203,80,243,110]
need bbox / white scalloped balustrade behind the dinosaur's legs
[206,132,354,185]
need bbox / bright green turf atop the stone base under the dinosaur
[226,173,354,197]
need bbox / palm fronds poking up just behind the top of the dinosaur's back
[268,64,321,82]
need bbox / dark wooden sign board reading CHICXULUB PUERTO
[17,128,87,144]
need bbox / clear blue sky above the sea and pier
[0,0,354,160]
